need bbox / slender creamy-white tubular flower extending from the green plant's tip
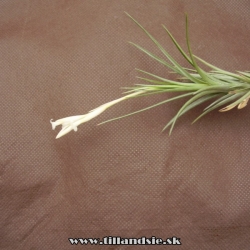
[50,91,144,139]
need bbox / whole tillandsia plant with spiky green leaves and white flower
[50,13,250,138]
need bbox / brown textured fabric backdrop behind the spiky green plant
[0,0,250,250]
